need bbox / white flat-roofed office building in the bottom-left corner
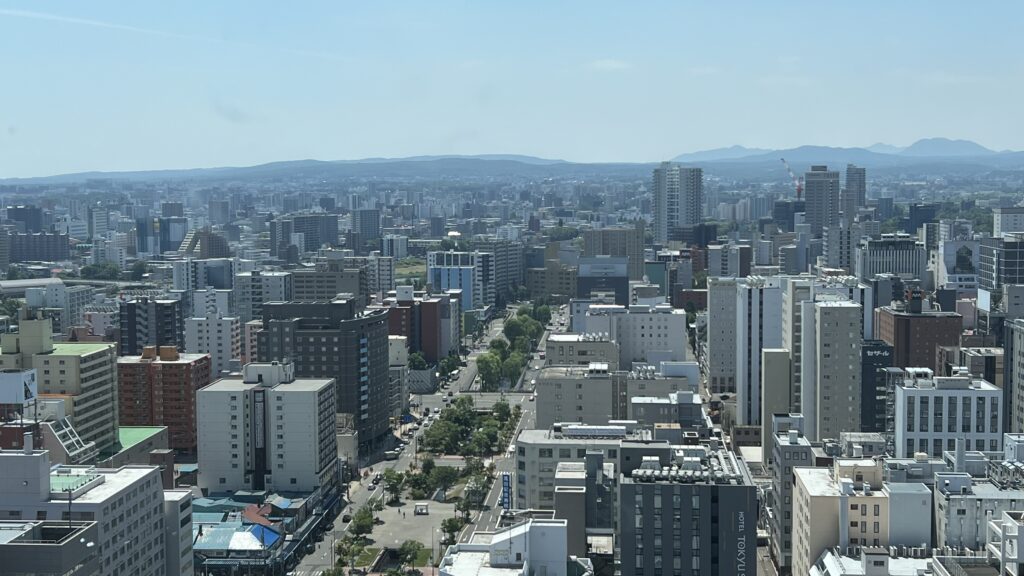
[0,449,171,576]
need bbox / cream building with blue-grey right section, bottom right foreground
[793,458,932,575]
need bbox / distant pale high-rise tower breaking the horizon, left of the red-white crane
[652,162,703,243]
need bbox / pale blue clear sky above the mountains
[0,0,1024,178]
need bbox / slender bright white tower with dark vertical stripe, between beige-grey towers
[734,276,782,425]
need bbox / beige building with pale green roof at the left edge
[0,311,118,448]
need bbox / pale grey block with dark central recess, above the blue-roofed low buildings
[197,362,340,494]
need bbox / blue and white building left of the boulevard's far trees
[427,251,497,311]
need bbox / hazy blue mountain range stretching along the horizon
[8,138,1024,184]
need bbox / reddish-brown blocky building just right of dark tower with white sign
[874,291,963,370]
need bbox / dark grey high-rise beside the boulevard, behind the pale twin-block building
[257,299,390,452]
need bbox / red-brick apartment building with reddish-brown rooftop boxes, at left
[118,346,210,453]
